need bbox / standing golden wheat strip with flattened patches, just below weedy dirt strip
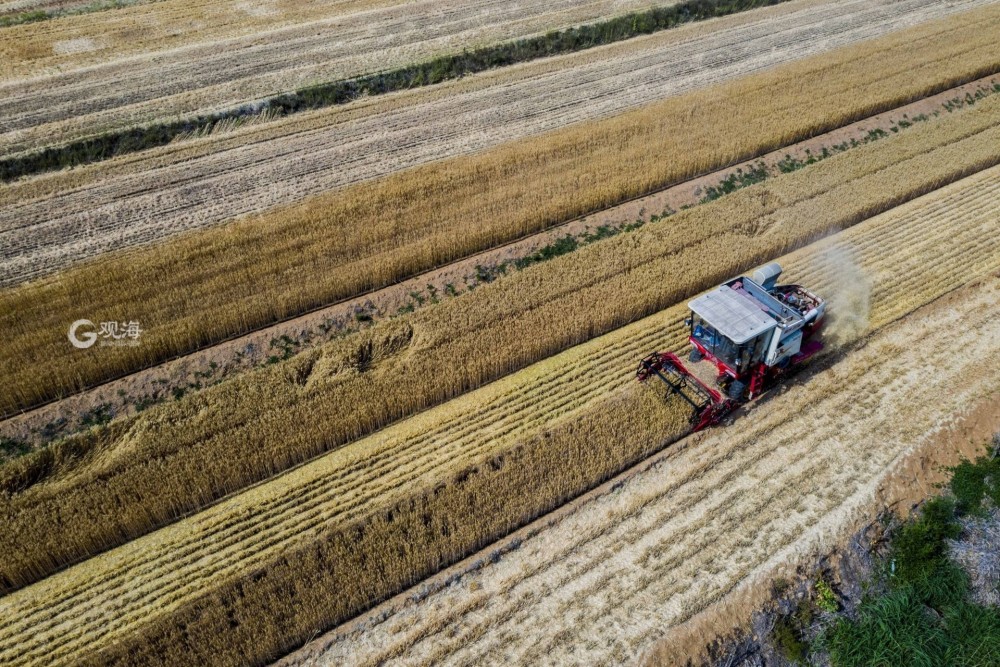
[0,94,1000,590]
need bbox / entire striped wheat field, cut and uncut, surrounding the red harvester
[0,0,1000,667]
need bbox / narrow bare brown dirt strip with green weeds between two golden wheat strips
[0,76,1000,444]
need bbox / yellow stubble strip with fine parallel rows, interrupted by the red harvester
[0,168,1000,664]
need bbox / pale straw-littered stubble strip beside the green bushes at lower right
[279,222,1000,667]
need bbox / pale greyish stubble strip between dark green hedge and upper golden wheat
[0,0,993,285]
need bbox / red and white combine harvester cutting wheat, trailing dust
[637,263,826,431]
